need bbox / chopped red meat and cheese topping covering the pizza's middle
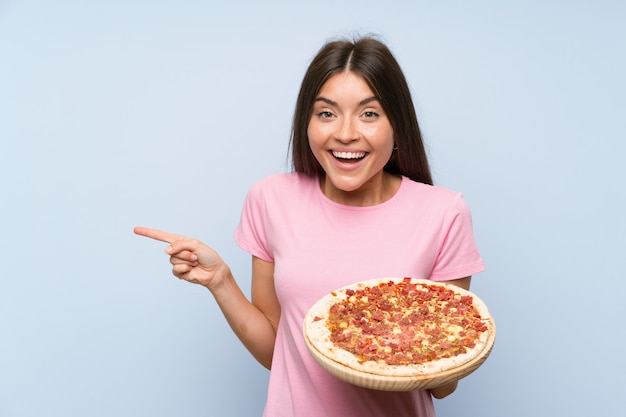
[326,278,488,365]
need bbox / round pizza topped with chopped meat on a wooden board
[304,278,495,386]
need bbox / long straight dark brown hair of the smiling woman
[290,37,433,185]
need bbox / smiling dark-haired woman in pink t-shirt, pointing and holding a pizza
[135,38,483,417]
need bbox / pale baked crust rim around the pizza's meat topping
[303,278,495,378]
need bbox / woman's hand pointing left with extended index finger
[134,227,229,290]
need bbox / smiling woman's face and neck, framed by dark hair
[307,71,395,205]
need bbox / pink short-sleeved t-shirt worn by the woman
[235,174,484,417]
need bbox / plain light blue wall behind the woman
[0,0,626,417]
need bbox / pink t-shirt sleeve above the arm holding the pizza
[431,193,485,281]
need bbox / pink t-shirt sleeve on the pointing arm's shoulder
[235,182,274,262]
